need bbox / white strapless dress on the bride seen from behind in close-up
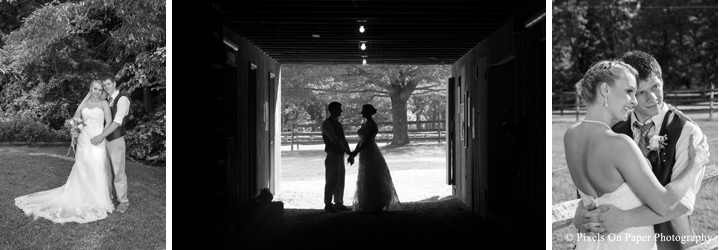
[576,182,657,250]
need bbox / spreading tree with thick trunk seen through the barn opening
[282,65,450,145]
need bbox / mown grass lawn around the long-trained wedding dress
[0,147,166,249]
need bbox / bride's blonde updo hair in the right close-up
[574,60,637,106]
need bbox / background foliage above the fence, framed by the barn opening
[282,64,450,145]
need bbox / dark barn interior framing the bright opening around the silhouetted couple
[172,0,546,249]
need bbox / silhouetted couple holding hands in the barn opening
[322,102,399,213]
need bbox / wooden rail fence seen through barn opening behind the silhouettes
[281,121,446,151]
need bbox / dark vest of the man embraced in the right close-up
[612,110,694,249]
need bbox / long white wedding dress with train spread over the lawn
[15,108,114,223]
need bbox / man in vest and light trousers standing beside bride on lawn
[90,75,130,213]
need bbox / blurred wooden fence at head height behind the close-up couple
[552,89,717,120]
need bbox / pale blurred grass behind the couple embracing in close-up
[551,113,717,249]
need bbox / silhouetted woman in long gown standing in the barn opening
[348,104,399,213]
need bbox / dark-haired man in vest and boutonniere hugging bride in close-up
[574,51,704,249]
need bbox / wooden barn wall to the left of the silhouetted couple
[223,24,280,227]
